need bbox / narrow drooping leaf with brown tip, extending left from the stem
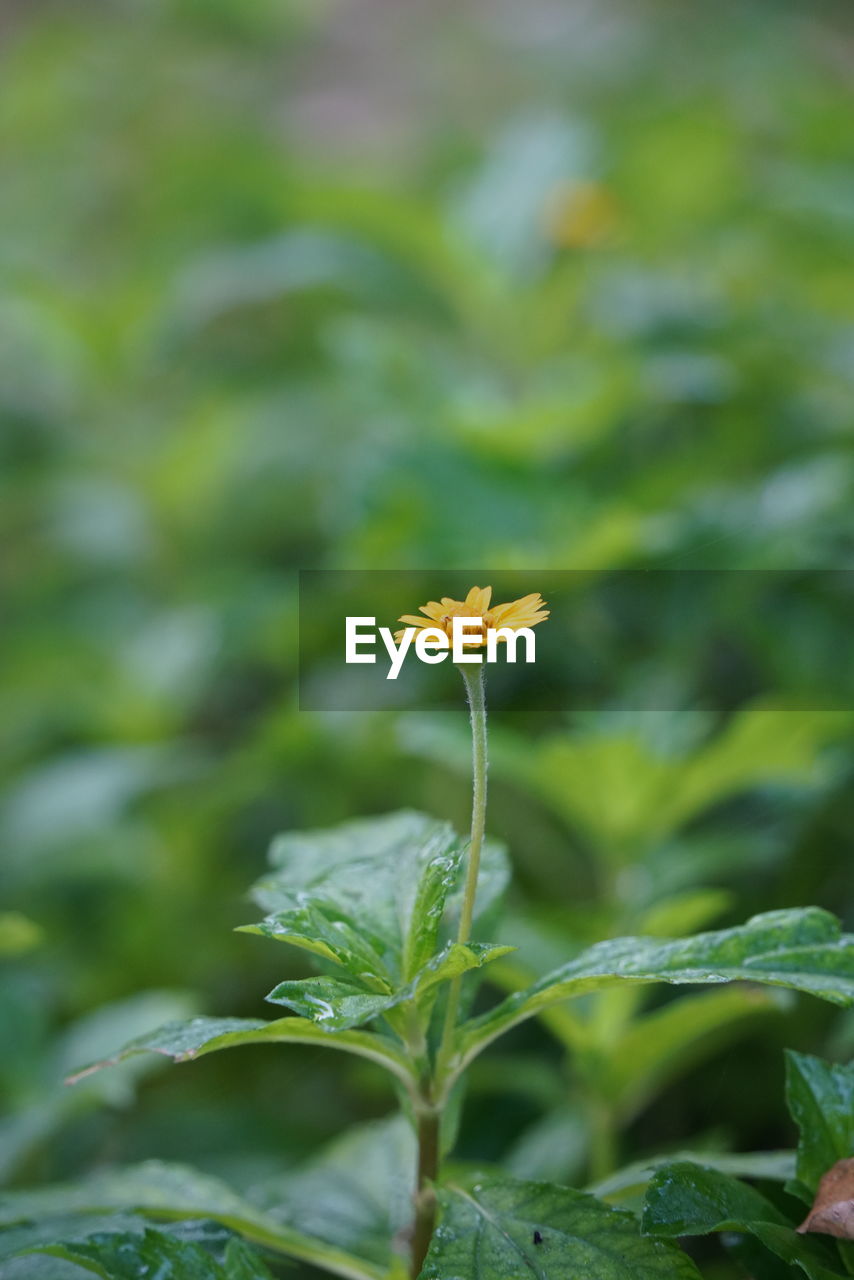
[69,1018,414,1089]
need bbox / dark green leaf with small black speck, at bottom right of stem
[421,1178,699,1280]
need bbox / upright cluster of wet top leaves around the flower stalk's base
[236,810,511,1030]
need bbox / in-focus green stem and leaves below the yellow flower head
[0,650,854,1280]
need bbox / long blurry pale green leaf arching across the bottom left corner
[0,1160,380,1280]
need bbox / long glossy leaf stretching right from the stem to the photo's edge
[456,908,854,1070]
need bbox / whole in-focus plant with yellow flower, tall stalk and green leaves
[1,588,854,1280]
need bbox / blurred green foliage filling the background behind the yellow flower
[0,0,854,1239]
